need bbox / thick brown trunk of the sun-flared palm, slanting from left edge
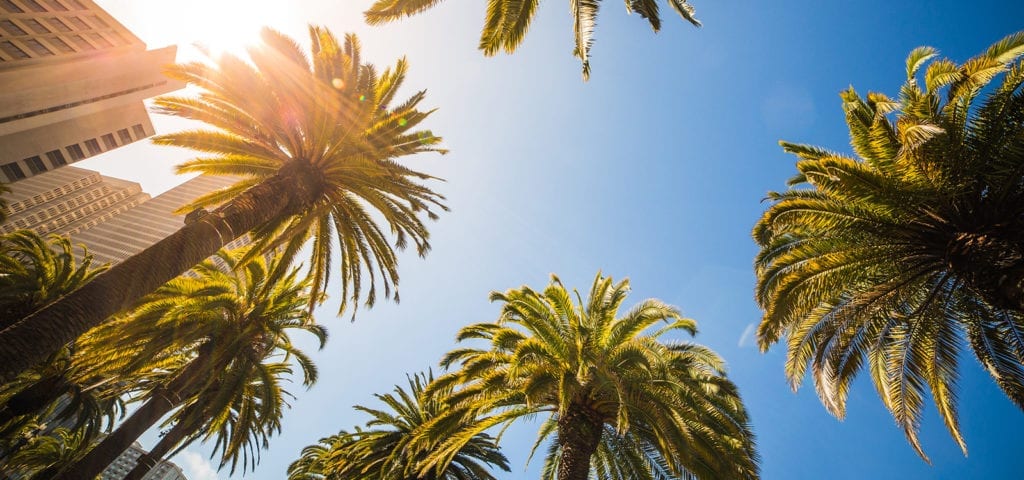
[0,168,316,382]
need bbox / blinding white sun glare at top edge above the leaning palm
[139,0,293,59]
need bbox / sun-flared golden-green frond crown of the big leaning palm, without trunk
[154,27,446,317]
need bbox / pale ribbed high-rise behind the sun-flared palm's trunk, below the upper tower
[0,167,237,264]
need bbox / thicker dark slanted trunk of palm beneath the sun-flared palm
[55,349,212,480]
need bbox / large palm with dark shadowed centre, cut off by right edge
[754,33,1024,460]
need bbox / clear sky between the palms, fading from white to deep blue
[87,0,1024,479]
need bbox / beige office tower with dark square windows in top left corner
[0,0,184,183]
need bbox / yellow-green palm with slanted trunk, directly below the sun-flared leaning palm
[55,252,327,480]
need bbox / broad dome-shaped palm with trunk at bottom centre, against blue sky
[424,273,758,480]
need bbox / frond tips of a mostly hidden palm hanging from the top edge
[364,0,700,80]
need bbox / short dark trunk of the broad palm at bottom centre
[558,406,602,480]
